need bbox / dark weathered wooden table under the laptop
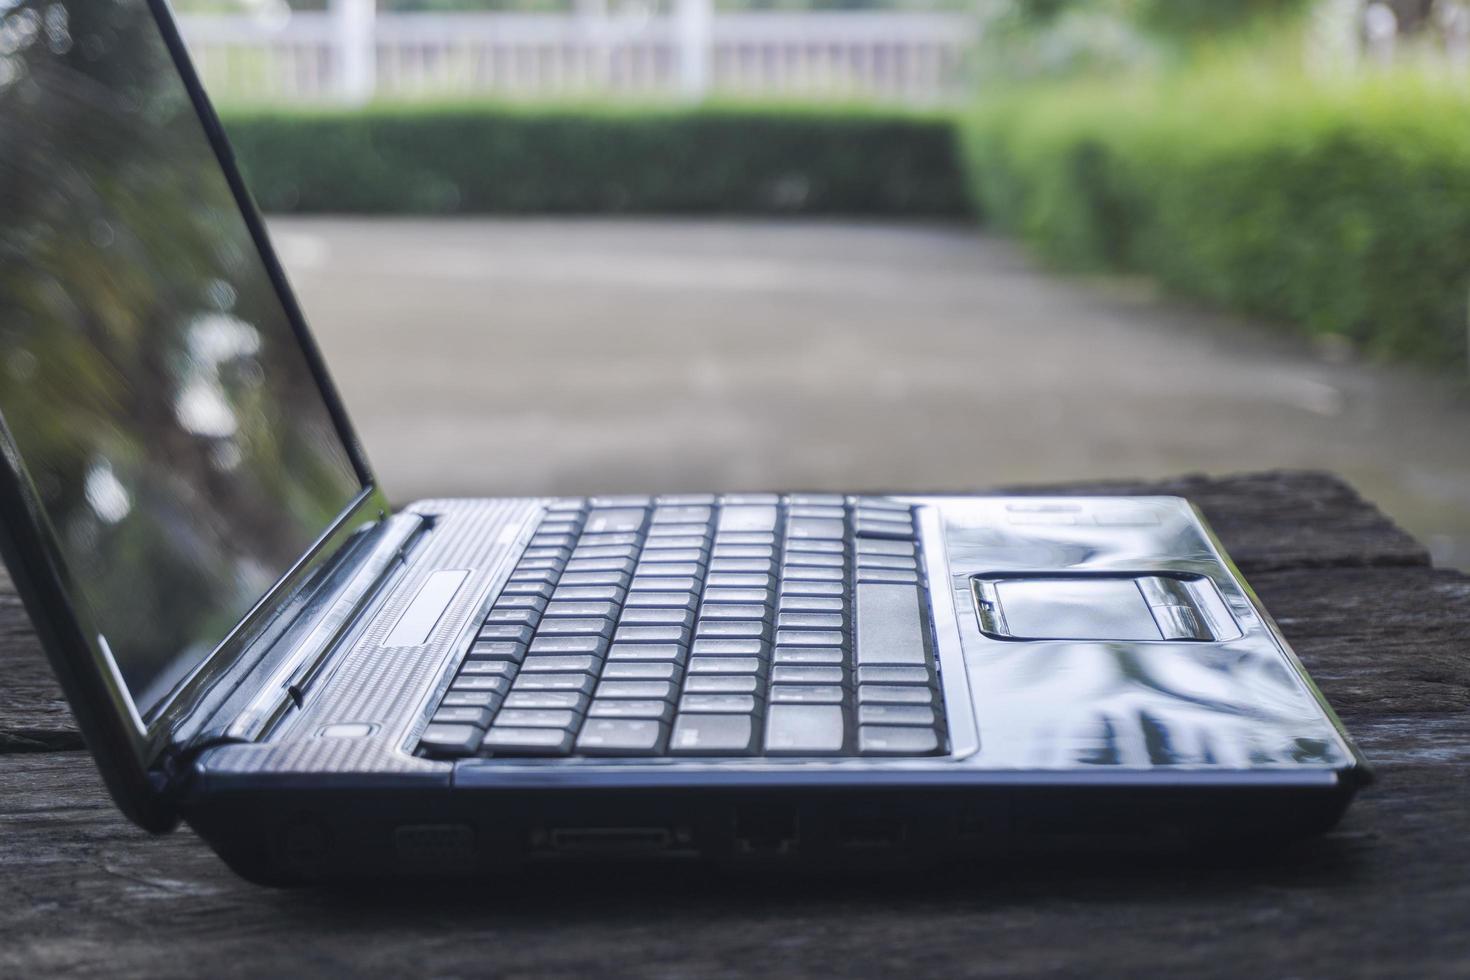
[0,473,1470,977]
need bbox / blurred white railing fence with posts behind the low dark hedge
[181,0,979,104]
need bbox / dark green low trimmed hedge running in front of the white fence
[225,106,969,215]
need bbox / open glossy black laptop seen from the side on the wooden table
[0,0,1369,883]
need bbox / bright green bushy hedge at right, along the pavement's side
[963,72,1470,360]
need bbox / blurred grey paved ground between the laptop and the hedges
[272,219,1470,567]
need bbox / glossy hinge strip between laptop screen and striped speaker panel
[216,513,432,742]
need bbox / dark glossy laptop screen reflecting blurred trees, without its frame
[0,0,362,717]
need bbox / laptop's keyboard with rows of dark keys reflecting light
[419,494,945,758]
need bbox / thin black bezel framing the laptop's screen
[0,0,390,830]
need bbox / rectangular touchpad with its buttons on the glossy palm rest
[973,574,1235,641]
